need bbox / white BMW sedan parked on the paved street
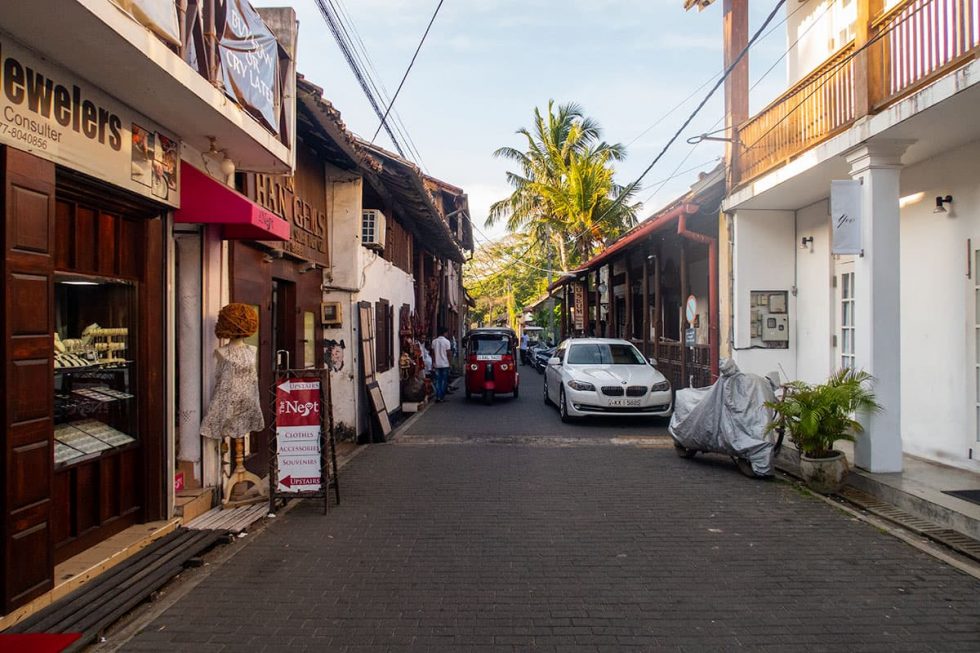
[544,338,673,422]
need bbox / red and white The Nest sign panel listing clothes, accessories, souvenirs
[276,378,323,493]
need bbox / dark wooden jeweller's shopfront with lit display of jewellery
[0,147,167,611]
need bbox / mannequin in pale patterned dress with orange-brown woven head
[201,304,265,504]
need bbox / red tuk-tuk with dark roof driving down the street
[463,327,520,405]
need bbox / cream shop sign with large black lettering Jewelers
[0,33,180,207]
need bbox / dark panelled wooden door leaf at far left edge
[0,147,55,612]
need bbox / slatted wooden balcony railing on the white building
[733,0,980,185]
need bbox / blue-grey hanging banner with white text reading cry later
[218,0,282,134]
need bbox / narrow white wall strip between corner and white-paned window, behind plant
[790,200,835,383]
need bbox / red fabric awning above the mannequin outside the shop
[174,161,289,240]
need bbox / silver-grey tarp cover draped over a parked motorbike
[670,359,776,476]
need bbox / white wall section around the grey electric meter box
[736,210,798,378]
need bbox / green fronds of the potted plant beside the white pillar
[766,368,881,458]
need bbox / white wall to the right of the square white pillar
[901,142,980,469]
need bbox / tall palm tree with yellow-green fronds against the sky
[486,100,625,270]
